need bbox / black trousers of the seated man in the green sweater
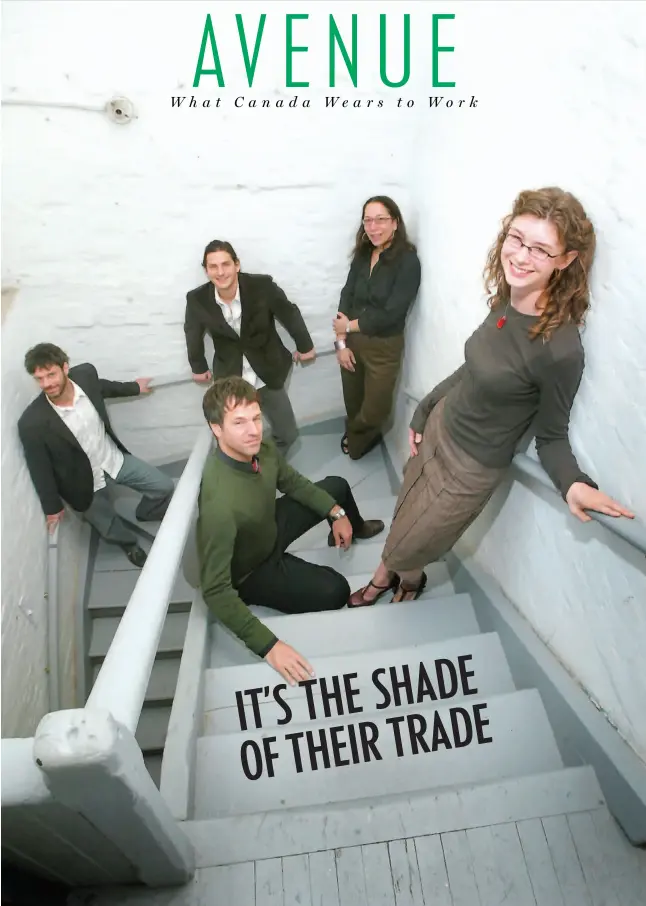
[238,476,370,613]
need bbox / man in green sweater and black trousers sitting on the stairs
[197,377,384,685]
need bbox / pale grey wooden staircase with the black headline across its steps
[73,425,646,906]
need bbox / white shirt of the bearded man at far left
[47,381,123,491]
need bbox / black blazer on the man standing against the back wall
[184,273,314,390]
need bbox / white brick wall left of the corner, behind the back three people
[2,0,428,735]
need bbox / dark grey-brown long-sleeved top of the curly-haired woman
[411,305,597,497]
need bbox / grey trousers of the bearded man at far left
[83,453,175,545]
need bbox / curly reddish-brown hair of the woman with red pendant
[483,187,596,340]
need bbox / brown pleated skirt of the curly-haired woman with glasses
[382,400,507,572]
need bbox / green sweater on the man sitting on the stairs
[197,442,336,657]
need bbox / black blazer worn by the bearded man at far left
[18,363,140,516]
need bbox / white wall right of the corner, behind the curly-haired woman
[391,2,646,759]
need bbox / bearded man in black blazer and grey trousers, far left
[18,343,175,567]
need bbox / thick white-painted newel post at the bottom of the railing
[33,708,195,887]
